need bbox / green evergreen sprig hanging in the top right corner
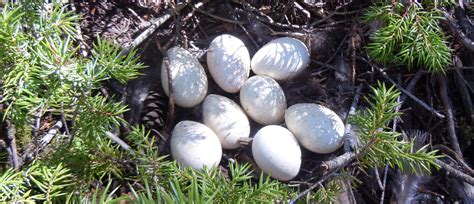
[364,3,451,72]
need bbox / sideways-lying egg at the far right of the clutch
[285,103,344,154]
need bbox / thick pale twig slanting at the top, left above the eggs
[123,4,185,54]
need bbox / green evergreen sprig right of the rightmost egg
[350,83,440,173]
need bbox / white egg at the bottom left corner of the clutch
[171,121,222,169]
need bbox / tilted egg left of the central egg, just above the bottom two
[202,94,250,149]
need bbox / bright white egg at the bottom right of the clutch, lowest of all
[252,125,301,181]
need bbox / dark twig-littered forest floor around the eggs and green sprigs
[71,0,474,203]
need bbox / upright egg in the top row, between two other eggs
[207,34,250,93]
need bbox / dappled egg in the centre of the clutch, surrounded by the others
[240,75,286,125]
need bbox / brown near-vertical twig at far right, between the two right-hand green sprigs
[437,74,463,158]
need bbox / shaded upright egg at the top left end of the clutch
[161,47,208,108]
